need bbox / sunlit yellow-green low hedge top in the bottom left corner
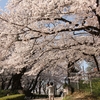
[0,94,25,100]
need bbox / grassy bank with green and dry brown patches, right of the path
[63,78,100,100]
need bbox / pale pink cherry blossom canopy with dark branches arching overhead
[0,0,100,93]
